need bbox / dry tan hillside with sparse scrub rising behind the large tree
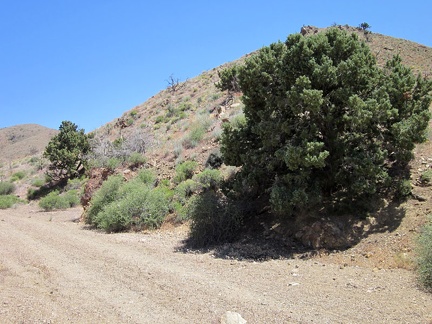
[94,26,432,182]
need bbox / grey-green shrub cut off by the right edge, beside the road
[417,215,432,290]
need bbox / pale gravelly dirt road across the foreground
[0,206,432,323]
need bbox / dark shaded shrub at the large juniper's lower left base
[186,190,243,247]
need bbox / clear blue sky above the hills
[0,0,432,131]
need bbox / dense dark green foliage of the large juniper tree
[219,28,432,215]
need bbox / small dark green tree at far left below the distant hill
[44,121,90,181]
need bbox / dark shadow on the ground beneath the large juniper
[176,195,405,261]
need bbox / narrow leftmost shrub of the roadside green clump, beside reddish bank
[86,175,124,224]
